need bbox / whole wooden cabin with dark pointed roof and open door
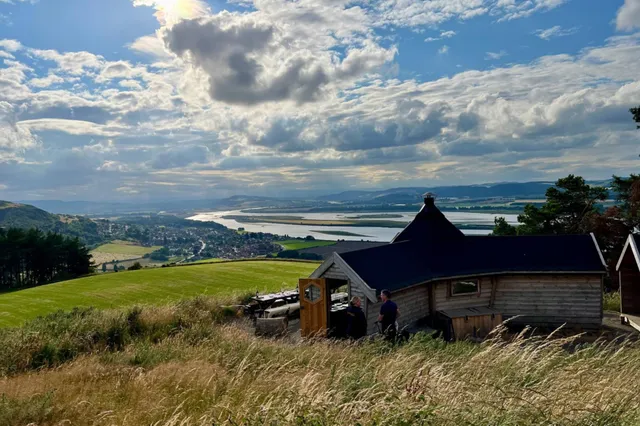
[300,194,606,338]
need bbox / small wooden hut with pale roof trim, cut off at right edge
[616,234,640,331]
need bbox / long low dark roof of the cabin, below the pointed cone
[340,235,605,292]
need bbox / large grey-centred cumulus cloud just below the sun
[164,12,395,105]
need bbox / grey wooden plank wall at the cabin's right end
[493,274,602,328]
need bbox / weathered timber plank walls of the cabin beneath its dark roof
[322,264,604,334]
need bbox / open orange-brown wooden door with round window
[298,278,329,337]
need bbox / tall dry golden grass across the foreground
[0,301,640,426]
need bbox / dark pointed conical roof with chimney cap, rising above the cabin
[392,194,464,244]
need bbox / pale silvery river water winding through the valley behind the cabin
[189,210,518,242]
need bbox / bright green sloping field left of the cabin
[0,261,318,327]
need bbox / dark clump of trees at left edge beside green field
[0,228,93,291]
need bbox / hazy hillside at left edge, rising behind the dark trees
[0,201,101,245]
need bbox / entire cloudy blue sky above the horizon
[0,0,640,201]
